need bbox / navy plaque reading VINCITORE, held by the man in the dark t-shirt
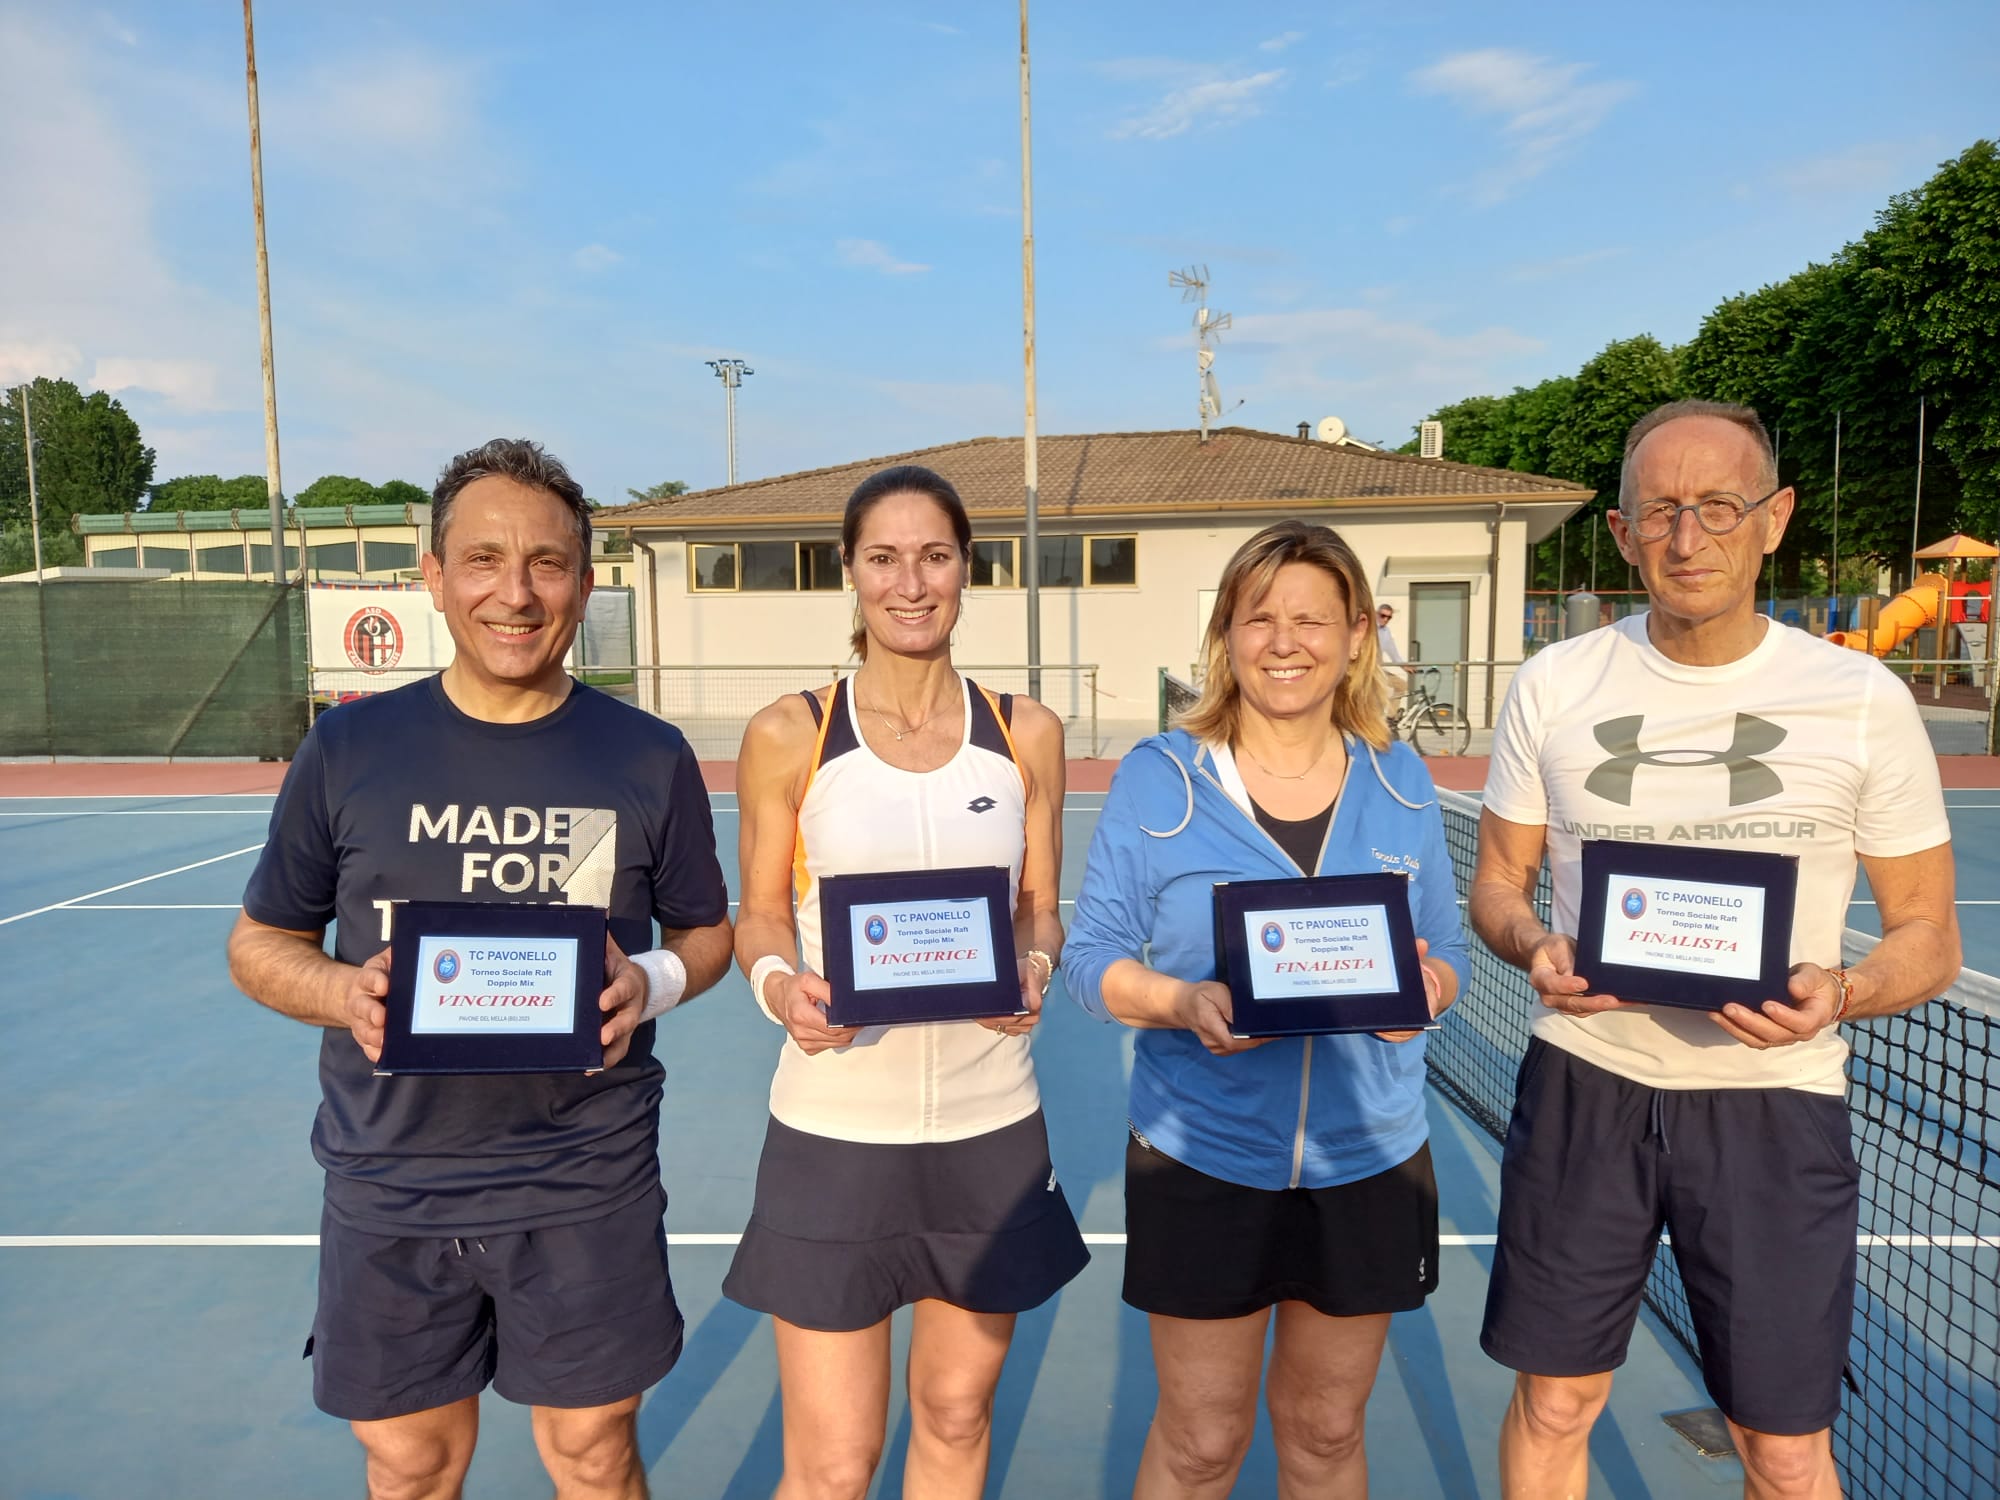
[376,902,604,1074]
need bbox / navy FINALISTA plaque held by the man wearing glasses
[1576,838,1798,1010]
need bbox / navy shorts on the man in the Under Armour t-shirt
[1480,1040,1860,1434]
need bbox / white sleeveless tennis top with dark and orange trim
[770,678,1042,1144]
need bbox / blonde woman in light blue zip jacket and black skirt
[1064,520,1466,1500]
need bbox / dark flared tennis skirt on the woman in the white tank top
[722,1110,1090,1332]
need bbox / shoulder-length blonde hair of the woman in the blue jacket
[1176,520,1390,750]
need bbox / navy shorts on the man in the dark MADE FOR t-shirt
[306,1190,682,1422]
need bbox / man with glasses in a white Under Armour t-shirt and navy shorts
[1470,402,1960,1498]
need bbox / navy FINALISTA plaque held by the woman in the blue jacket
[1214,874,1436,1036]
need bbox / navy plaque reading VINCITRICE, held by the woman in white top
[820,864,1022,1026]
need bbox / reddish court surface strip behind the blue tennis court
[0,756,2000,796]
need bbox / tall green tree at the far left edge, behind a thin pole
[0,378,154,566]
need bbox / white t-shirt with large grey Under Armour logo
[1486,614,1952,1094]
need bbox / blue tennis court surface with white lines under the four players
[0,792,2000,1500]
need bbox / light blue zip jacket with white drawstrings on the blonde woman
[1062,730,1466,1188]
